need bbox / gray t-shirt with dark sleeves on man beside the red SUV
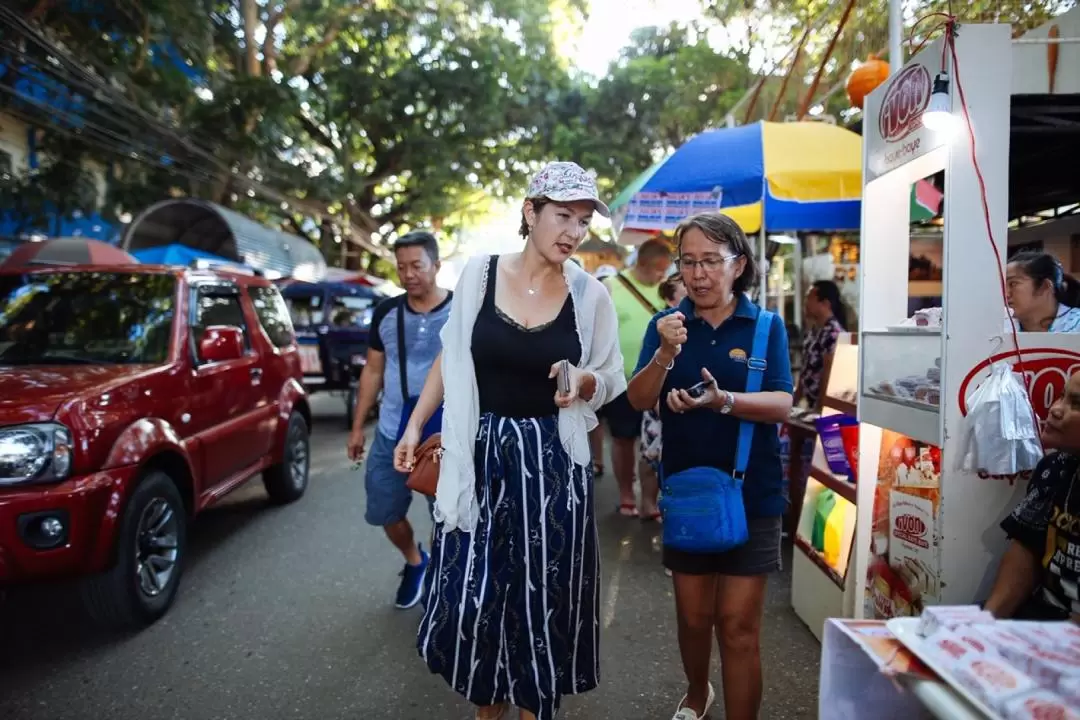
[368,293,454,438]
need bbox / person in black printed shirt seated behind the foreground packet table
[985,372,1080,622]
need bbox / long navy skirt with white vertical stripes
[417,413,599,720]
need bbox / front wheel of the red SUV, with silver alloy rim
[82,471,188,628]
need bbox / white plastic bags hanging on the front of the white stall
[961,363,1042,475]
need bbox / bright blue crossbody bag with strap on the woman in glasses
[660,310,772,553]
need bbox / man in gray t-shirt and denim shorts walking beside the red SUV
[348,232,453,608]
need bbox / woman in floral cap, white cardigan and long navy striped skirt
[395,162,626,720]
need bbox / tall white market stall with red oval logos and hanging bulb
[793,18,1080,647]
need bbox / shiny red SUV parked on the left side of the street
[0,266,311,627]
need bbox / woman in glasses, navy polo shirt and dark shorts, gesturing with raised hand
[627,214,792,720]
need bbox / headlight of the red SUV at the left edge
[0,422,72,485]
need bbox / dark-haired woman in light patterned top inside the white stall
[1005,252,1080,332]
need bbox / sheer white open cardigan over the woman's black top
[435,255,626,532]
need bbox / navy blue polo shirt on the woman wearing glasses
[637,294,793,517]
